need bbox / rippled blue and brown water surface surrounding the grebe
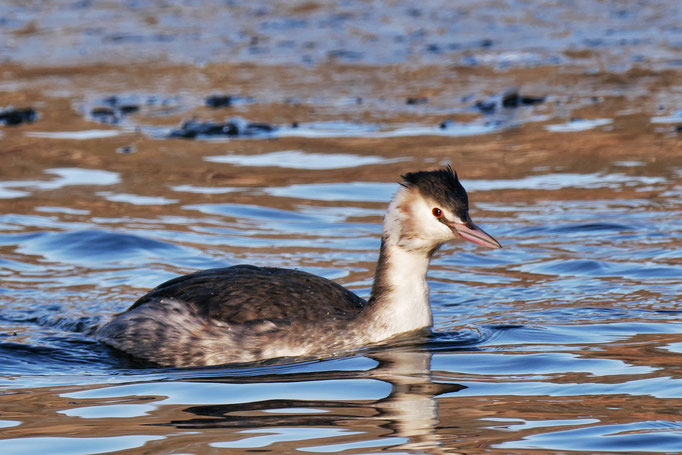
[0,1,682,454]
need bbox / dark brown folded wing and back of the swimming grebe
[128,265,366,325]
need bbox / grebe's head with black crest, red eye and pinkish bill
[384,166,501,255]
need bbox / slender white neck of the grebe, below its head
[368,232,433,341]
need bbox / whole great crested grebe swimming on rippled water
[95,166,500,367]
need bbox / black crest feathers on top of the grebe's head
[402,165,469,221]
